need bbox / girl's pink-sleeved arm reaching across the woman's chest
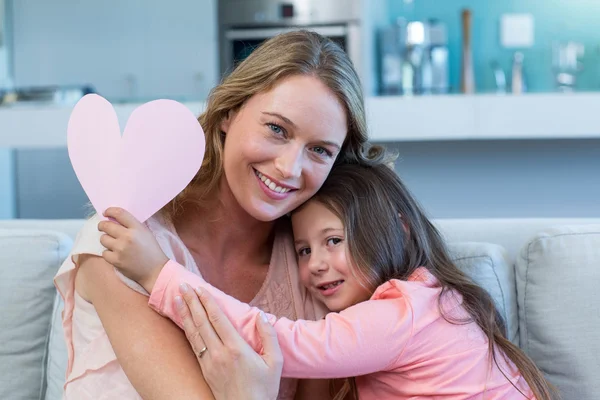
[149,261,412,378]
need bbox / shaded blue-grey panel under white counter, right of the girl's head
[389,139,600,218]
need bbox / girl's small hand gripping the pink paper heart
[98,207,169,293]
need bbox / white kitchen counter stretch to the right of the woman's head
[367,93,600,142]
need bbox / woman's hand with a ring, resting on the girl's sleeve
[175,284,283,400]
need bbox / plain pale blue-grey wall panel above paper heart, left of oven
[9,0,218,101]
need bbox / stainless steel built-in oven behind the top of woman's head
[218,0,387,94]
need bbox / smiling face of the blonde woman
[221,76,347,221]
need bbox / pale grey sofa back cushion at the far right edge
[516,225,600,400]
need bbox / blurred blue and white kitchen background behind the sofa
[0,0,600,219]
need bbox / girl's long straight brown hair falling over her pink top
[313,164,554,400]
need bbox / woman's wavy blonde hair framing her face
[163,30,383,218]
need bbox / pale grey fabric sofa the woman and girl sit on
[0,219,600,400]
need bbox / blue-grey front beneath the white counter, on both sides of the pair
[16,139,600,218]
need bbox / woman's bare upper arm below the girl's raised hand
[77,255,213,400]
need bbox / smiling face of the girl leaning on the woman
[292,200,371,312]
